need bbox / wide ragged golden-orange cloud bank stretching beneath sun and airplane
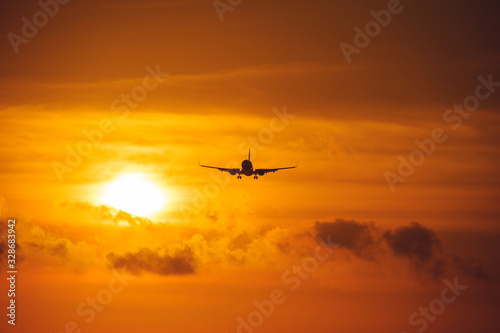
[48,202,296,275]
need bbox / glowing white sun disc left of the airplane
[100,173,168,217]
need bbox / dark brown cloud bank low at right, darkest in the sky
[314,219,487,280]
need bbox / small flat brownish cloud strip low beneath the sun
[106,247,195,275]
